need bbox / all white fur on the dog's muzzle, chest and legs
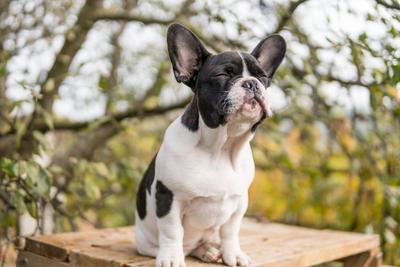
[136,57,268,267]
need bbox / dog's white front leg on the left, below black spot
[156,191,186,267]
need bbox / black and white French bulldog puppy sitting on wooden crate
[136,24,286,267]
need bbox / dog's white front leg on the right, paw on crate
[220,195,250,266]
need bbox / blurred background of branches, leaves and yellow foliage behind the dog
[0,0,400,266]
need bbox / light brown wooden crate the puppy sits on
[17,219,381,267]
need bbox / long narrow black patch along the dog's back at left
[136,155,157,220]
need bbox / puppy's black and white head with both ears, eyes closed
[167,24,286,130]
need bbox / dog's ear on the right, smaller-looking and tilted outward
[251,34,286,79]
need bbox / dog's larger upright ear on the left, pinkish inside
[167,23,210,90]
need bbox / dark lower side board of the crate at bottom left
[17,251,71,267]
